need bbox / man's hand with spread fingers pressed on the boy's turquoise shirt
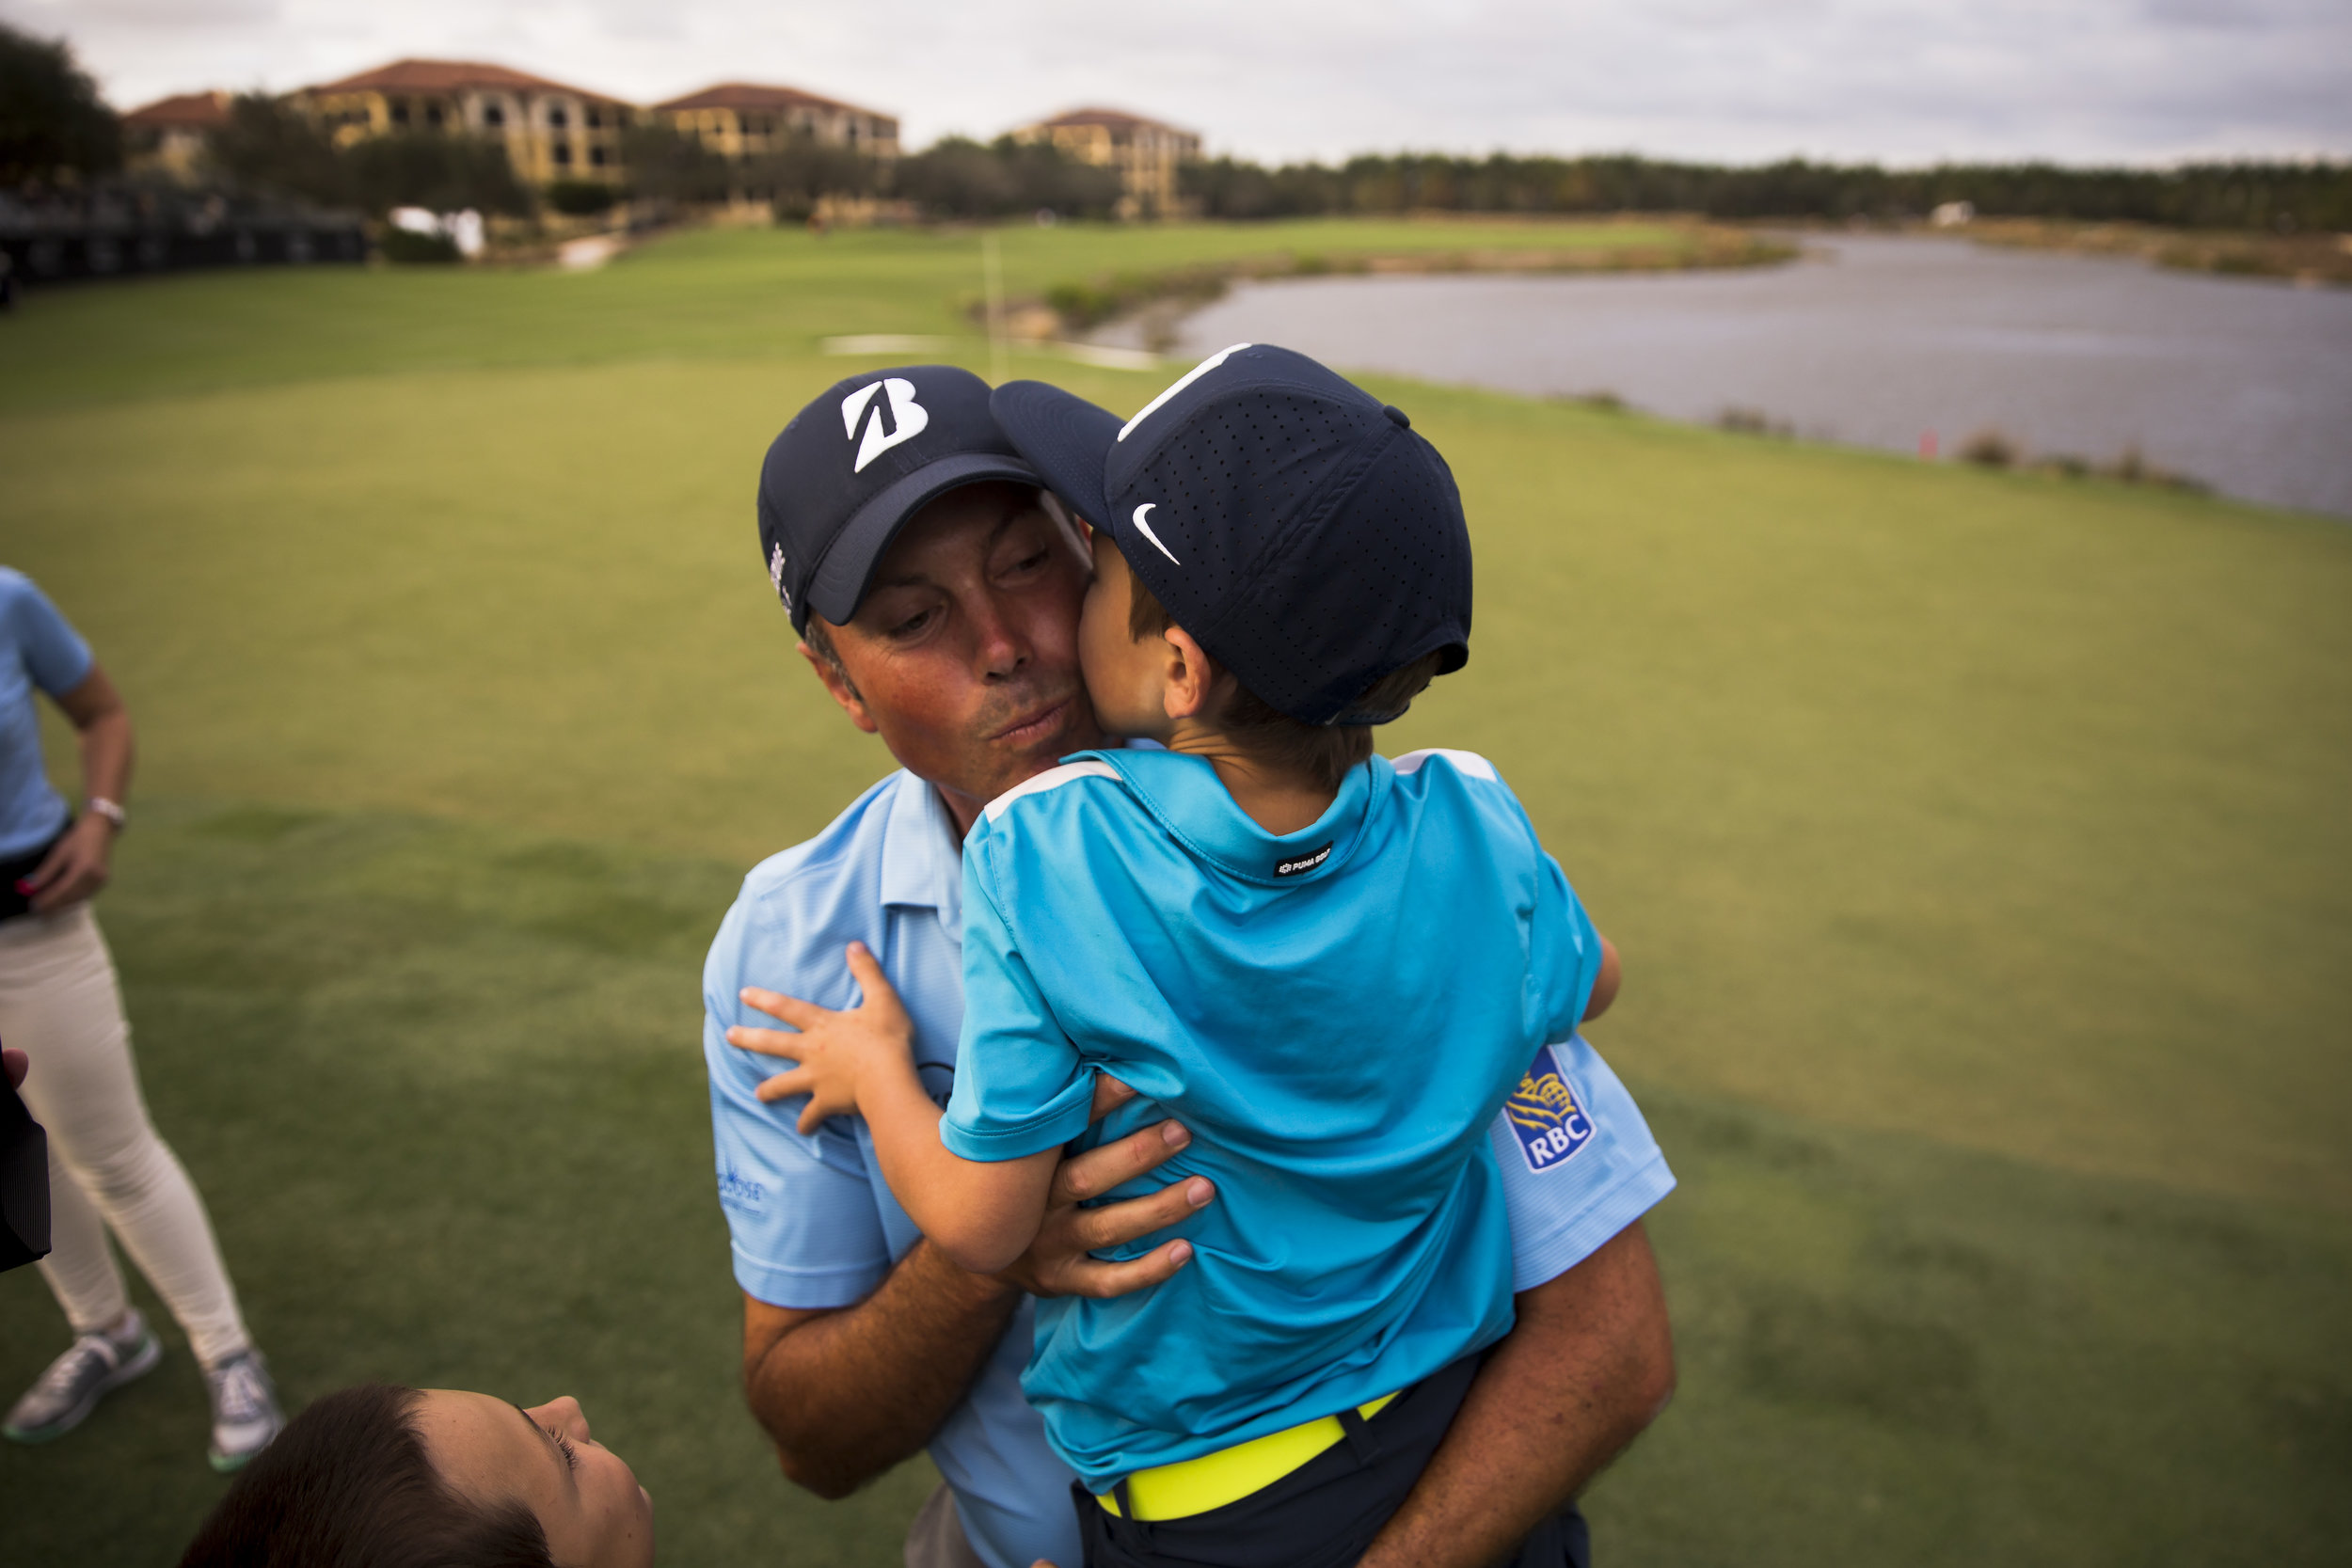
[997,1074,1216,1298]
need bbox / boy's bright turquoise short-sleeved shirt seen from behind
[941,750,1599,1491]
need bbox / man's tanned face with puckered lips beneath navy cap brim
[803,484,1101,828]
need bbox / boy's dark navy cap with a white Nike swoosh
[988,343,1470,724]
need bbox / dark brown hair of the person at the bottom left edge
[179,1383,555,1568]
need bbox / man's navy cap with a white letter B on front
[760,364,1042,632]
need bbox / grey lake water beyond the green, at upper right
[1148,235,2352,517]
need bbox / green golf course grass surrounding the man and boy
[0,223,2352,1568]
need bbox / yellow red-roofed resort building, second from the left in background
[292,58,638,185]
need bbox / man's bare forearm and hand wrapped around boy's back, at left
[743,1100,1214,1497]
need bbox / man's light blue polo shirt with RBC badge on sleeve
[704,771,1675,1568]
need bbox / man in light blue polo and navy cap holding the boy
[706,367,1673,1568]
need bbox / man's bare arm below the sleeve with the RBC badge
[1359,1220,1675,1568]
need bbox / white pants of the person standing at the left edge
[0,903,249,1366]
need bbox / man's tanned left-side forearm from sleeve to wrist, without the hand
[743,1242,1021,1497]
